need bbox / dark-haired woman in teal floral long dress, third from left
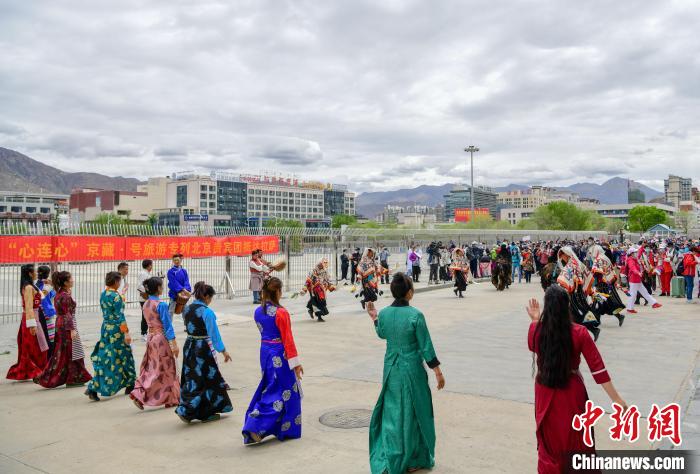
[85,272,136,402]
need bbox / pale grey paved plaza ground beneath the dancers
[0,281,700,474]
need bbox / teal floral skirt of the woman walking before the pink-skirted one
[88,321,136,397]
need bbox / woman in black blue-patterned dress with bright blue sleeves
[175,281,233,423]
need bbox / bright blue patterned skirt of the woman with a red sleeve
[243,343,301,444]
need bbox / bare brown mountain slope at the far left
[0,147,141,194]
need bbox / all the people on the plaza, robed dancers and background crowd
[7,238,700,473]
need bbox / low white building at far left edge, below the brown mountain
[0,191,69,225]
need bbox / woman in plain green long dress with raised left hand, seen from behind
[367,273,445,474]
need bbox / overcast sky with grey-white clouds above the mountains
[0,0,700,191]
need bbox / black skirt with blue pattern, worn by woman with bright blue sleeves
[175,337,233,420]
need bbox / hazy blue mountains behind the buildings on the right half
[355,178,664,218]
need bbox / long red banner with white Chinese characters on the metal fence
[0,235,280,263]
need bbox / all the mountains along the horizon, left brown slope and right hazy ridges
[0,147,663,218]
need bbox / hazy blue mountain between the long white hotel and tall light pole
[355,184,455,219]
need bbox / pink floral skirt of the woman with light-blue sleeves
[131,333,180,407]
